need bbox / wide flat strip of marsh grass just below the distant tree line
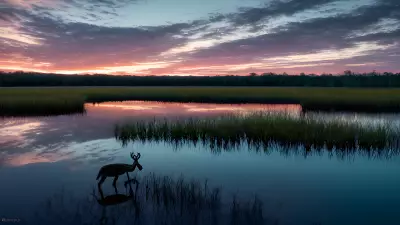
[0,87,400,115]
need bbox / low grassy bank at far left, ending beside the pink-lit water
[0,96,85,117]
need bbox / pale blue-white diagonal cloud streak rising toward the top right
[158,0,375,55]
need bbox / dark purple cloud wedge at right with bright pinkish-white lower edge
[168,2,400,74]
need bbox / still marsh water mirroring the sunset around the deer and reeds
[0,101,400,225]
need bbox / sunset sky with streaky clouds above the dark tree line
[0,0,400,75]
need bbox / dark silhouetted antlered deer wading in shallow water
[96,152,143,193]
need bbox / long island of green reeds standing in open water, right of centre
[115,113,398,150]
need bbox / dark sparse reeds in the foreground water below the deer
[36,174,272,225]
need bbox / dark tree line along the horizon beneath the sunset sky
[0,71,400,87]
